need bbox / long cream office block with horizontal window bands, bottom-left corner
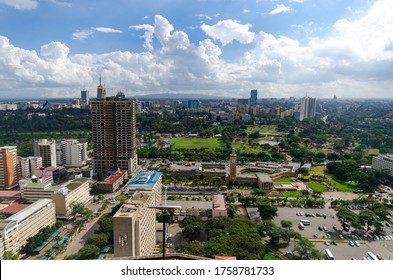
[0,199,56,256]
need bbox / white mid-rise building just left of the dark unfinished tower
[56,139,87,167]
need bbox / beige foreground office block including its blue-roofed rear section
[113,172,162,257]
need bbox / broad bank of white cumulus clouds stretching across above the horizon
[0,0,393,97]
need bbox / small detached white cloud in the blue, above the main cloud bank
[201,19,255,46]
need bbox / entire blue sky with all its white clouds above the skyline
[0,0,393,98]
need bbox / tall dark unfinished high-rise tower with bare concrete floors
[91,97,138,176]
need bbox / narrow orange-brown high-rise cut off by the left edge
[0,146,18,189]
